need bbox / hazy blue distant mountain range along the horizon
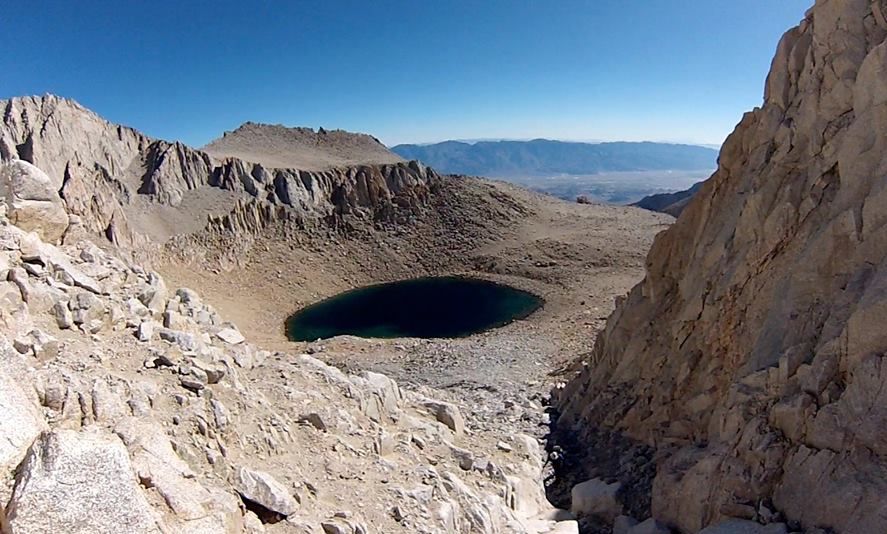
[391,139,718,178]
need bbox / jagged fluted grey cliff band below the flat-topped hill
[0,95,441,247]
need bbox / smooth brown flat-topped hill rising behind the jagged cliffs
[202,122,403,171]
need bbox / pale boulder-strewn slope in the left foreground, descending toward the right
[0,162,576,533]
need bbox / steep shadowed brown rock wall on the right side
[559,0,887,533]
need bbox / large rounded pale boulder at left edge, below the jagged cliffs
[0,160,68,243]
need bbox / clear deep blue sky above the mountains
[0,0,812,146]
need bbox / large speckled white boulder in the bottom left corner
[6,430,160,534]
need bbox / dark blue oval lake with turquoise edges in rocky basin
[286,276,544,341]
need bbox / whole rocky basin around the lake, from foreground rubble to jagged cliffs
[0,96,668,534]
